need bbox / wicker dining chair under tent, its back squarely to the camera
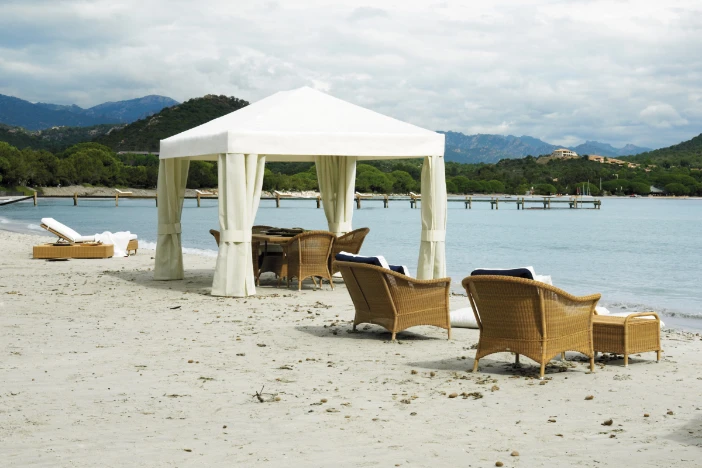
[285,231,336,290]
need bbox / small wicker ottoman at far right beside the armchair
[592,312,661,367]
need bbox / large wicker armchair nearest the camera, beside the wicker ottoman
[462,276,600,379]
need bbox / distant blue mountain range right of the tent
[439,131,651,164]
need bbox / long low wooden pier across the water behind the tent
[23,192,602,210]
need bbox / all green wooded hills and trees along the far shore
[0,95,702,195]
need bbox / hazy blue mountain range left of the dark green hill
[0,94,179,130]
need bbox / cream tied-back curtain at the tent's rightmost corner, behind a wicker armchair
[417,156,447,279]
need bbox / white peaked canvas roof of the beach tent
[160,86,444,161]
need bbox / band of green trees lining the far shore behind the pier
[0,142,702,195]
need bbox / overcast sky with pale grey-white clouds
[0,0,702,148]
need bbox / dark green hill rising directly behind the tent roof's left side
[95,94,249,151]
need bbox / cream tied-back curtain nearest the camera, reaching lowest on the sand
[212,154,266,297]
